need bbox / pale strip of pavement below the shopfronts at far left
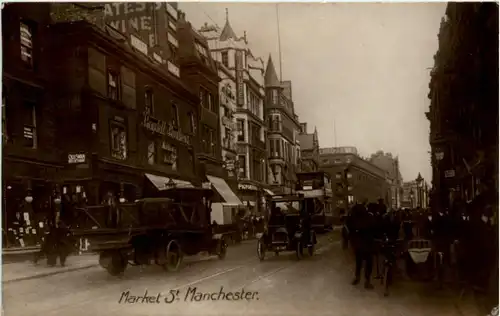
[2,254,99,284]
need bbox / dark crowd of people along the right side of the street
[341,196,498,289]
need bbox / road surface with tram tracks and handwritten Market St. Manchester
[3,234,470,316]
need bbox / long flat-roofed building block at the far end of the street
[320,147,390,209]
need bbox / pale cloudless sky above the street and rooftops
[179,2,446,182]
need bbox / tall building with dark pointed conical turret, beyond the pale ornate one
[265,56,300,194]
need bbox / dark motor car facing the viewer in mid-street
[257,195,317,261]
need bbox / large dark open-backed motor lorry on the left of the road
[72,188,227,276]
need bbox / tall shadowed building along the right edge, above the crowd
[426,3,498,207]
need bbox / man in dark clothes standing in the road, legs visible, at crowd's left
[348,201,374,289]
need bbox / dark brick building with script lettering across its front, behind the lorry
[50,22,198,204]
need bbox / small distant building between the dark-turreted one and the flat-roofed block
[297,123,319,172]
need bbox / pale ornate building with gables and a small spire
[199,11,267,213]
